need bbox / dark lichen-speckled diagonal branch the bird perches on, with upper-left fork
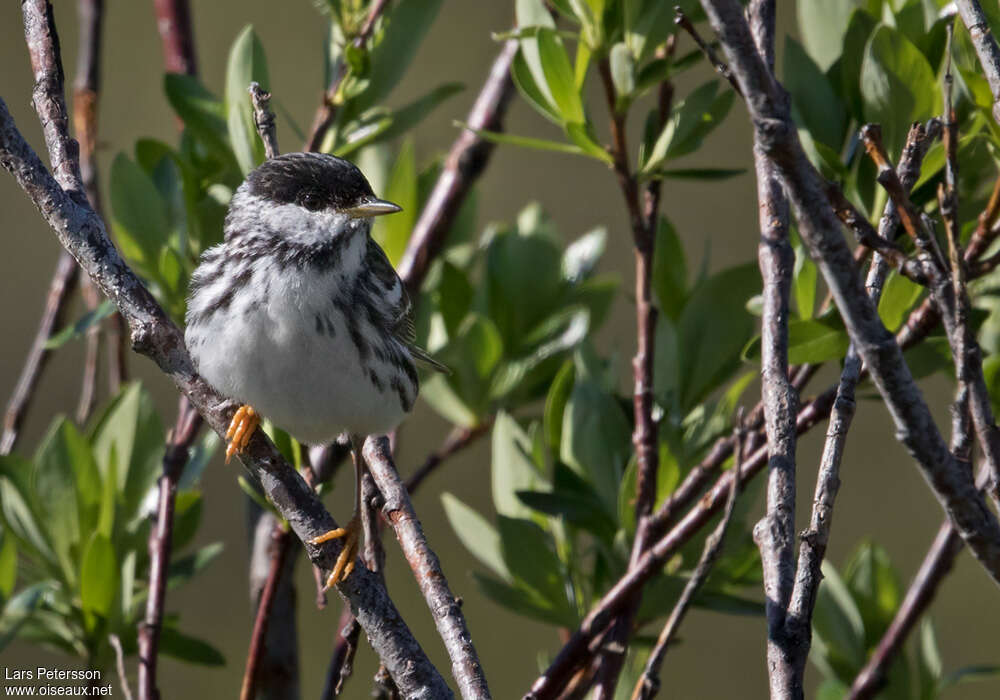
[0,6,451,698]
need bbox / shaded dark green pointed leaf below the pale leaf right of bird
[497,515,567,609]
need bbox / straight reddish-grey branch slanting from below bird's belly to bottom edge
[364,437,490,699]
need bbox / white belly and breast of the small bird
[189,268,404,443]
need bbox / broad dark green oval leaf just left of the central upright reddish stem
[560,377,630,512]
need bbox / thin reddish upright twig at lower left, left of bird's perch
[138,396,202,700]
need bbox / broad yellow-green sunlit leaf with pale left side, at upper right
[861,26,941,160]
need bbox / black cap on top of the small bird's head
[247,153,375,211]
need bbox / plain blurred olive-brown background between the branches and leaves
[0,0,1000,698]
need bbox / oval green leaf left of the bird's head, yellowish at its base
[111,153,170,275]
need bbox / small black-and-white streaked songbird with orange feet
[185,153,443,586]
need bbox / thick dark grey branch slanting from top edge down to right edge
[702,0,1000,583]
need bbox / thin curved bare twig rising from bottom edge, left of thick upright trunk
[632,415,743,700]
